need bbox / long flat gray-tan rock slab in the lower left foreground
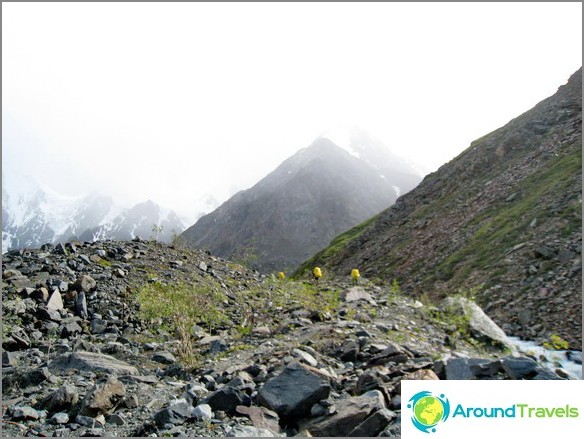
[49,351,138,375]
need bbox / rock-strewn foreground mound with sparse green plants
[2,240,581,437]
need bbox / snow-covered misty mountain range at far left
[2,178,184,253]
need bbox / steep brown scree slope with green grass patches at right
[297,69,582,346]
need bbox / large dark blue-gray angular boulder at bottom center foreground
[257,363,331,418]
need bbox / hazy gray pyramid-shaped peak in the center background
[182,137,420,272]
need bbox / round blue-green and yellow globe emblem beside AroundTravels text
[408,390,450,433]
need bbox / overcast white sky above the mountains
[2,3,582,225]
